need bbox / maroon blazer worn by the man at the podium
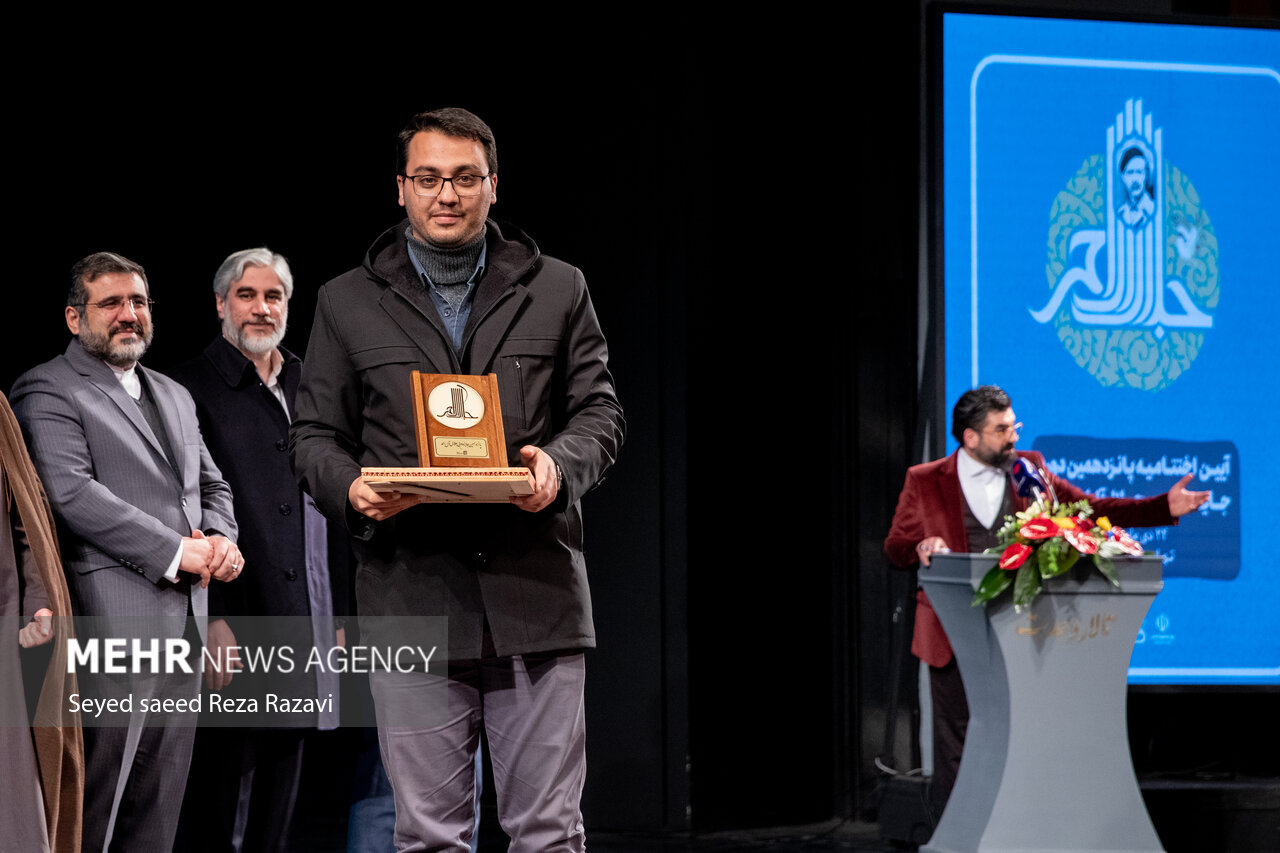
[884,448,1178,666]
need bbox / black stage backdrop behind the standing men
[0,4,1269,831]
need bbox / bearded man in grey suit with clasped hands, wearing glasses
[10,252,242,853]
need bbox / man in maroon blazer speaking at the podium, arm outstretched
[884,386,1210,809]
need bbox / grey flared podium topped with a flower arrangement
[919,553,1164,853]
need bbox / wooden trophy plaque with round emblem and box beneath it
[361,370,534,503]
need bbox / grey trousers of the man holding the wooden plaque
[370,652,586,853]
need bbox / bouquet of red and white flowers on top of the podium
[973,501,1142,611]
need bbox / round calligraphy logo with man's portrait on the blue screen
[1029,99,1220,391]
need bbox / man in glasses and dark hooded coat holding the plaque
[292,109,625,850]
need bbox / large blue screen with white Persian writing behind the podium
[942,14,1280,684]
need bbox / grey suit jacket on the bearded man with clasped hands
[10,338,237,640]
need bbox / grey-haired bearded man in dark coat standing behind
[172,247,347,850]
